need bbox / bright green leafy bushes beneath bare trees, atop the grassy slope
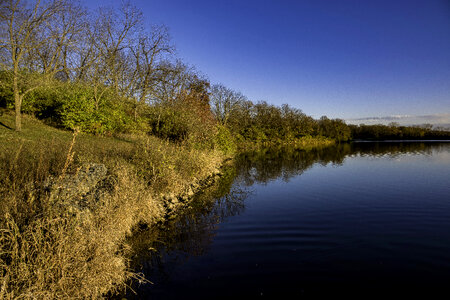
[9,81,136,134]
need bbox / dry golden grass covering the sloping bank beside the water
[0,114,222,299]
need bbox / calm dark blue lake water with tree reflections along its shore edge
[127,142,450,299]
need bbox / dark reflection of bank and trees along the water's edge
[128,142,450,298]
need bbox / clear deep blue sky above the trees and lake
[85,0,450,123]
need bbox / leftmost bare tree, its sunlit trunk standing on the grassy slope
[0,0,63,131]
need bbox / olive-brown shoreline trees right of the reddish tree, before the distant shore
[211,85,351,148]
